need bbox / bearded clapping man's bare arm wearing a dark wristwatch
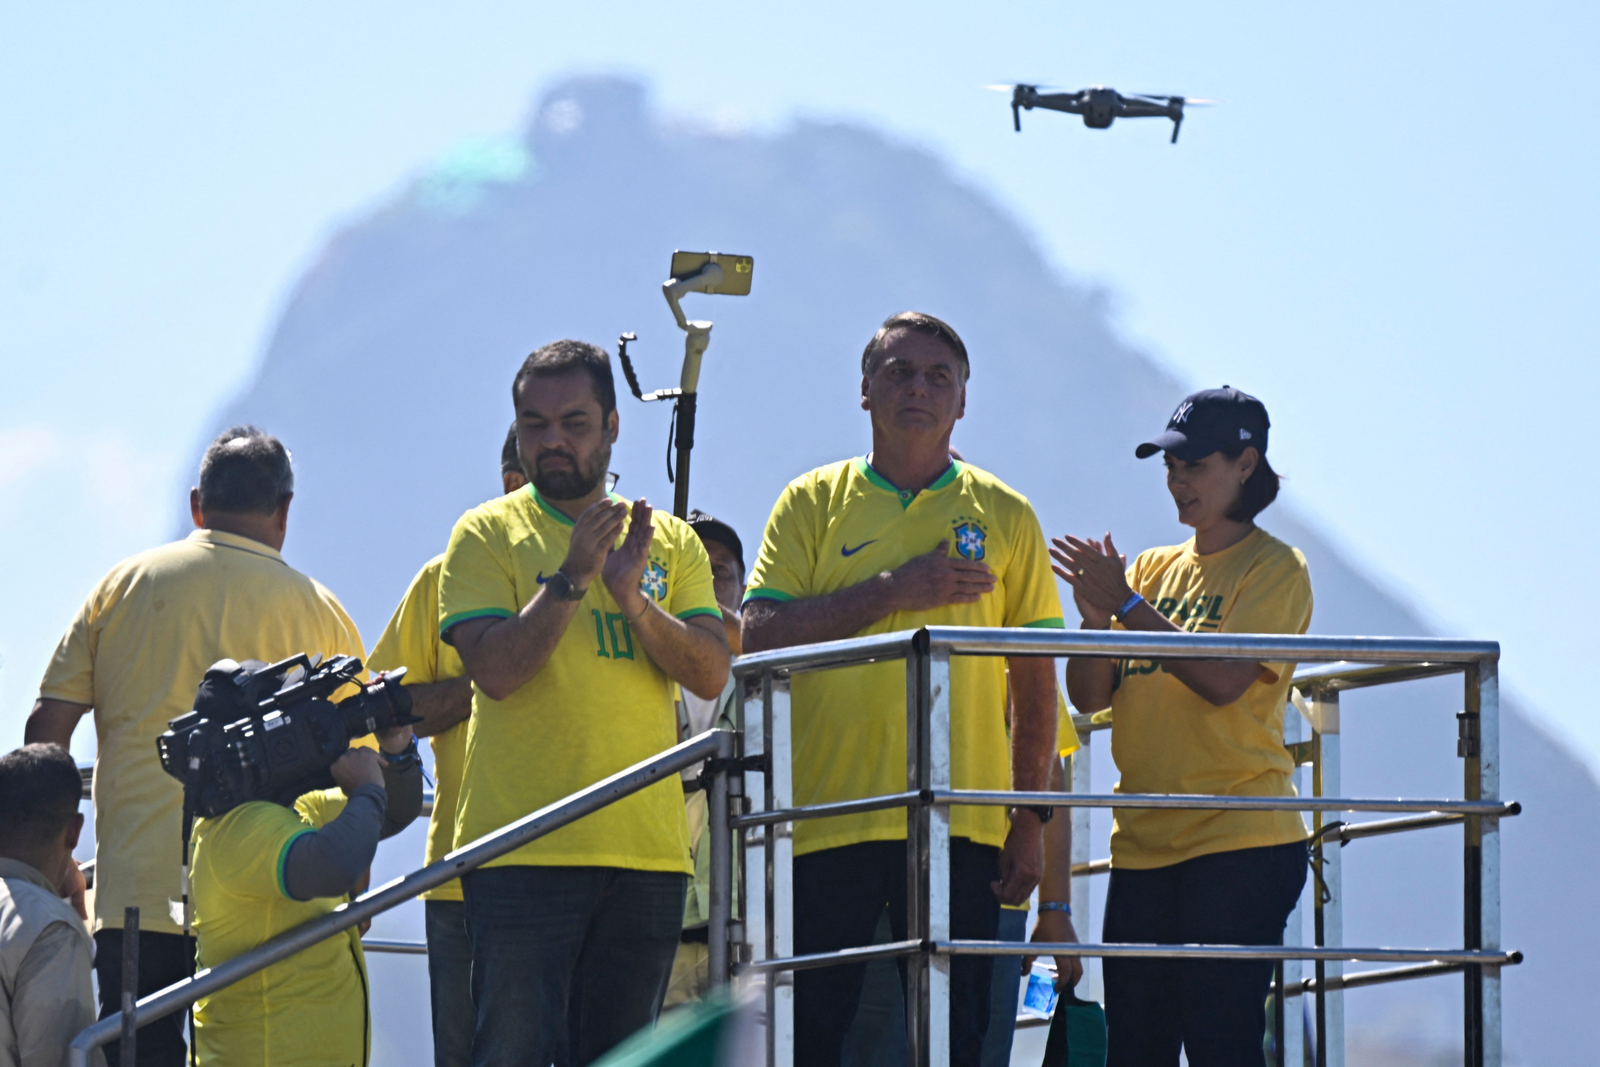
[446,499,627,701]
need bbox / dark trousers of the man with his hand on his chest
[794,838,1000,1067]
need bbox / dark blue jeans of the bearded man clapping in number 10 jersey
[461,867,686,1067]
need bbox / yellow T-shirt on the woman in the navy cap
[1110,530,1312,869]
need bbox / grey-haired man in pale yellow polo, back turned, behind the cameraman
[24,426,366,1067]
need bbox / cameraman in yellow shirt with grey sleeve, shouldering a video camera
[192,716,422,1067]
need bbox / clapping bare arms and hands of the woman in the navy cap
[1050,533,1277,710]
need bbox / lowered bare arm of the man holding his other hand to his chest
[990,656,1056,904]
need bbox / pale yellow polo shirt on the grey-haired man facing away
[38,530,365,934]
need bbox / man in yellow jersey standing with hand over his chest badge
[742,312,1062,1067]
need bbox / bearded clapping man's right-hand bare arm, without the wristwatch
[600,499,733,701]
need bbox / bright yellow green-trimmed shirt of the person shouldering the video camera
[192,789,371,1067]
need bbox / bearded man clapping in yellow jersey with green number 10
[438,341,730,1067]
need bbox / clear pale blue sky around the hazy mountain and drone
[0,0,1600,777]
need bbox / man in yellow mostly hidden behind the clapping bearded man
[366,424,528,1067]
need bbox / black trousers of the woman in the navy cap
[1101,843,1307,1067]
